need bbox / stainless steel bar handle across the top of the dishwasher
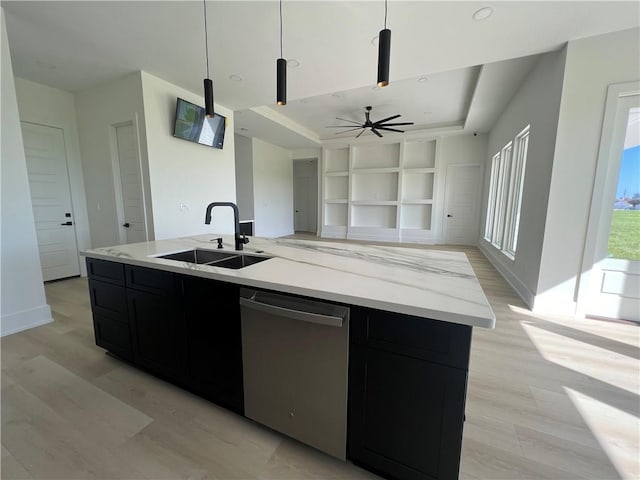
[240,291,349,327]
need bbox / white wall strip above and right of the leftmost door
[15,78,91,275]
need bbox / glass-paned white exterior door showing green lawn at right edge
[585,91,640,322]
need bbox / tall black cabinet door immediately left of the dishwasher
[183,277,244,414]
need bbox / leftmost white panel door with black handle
[21,122,80,281]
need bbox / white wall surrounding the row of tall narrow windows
[479,49,565,305]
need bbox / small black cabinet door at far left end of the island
[89,279,131,360]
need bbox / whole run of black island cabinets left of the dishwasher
[87,258,244,413]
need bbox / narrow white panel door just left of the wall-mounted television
[115,123,147,243]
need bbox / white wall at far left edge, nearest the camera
[0,8,52,335]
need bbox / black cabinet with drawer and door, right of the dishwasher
[348,309,471,480]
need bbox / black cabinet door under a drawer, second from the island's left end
[127,289,185,382]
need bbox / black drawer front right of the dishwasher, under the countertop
[351,308,471,370]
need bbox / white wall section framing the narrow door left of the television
[75,72,153,251]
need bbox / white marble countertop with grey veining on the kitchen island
[82,234,495,328]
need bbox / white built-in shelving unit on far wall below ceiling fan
[322,139,437,242]
